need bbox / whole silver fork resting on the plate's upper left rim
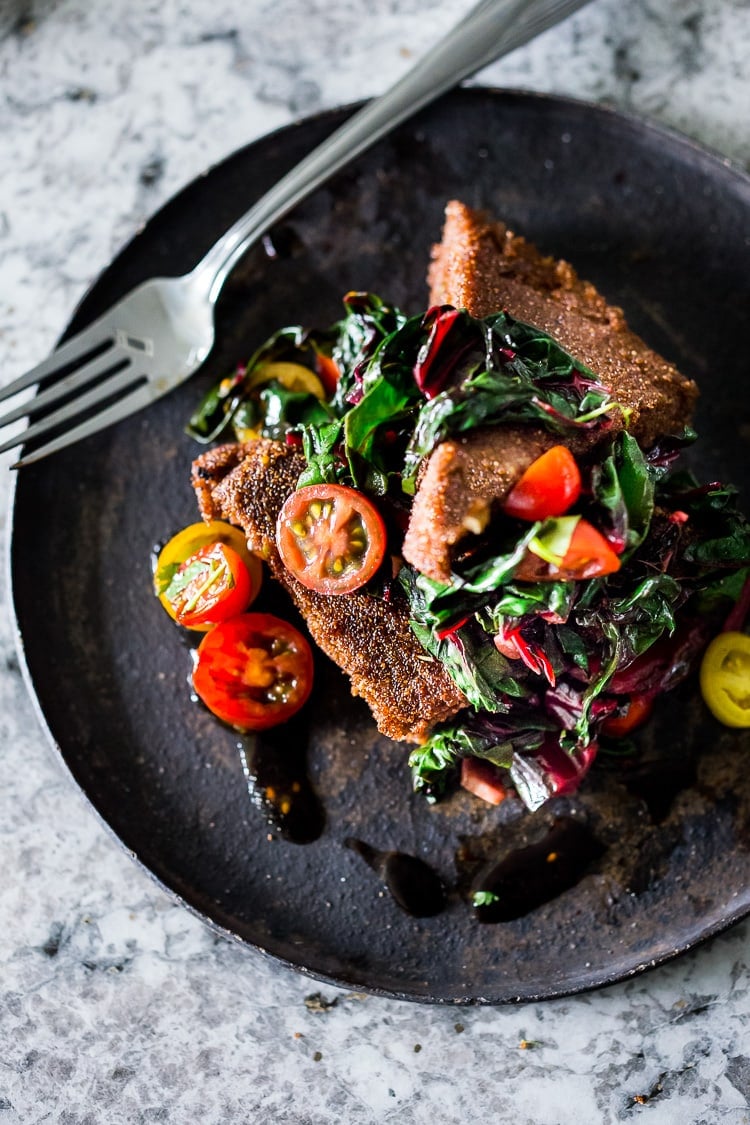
[0,0,587,468]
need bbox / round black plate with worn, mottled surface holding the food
[12,90,750,1002]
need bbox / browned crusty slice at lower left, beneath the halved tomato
[192,441,467,743]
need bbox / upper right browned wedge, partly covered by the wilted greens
[404,201,697,582]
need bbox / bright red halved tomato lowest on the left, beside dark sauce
[192,613,313,730]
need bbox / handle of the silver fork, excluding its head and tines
[192,0,587,300]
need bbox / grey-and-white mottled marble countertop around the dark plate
[0,0,750,1125]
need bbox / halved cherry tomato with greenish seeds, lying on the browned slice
[277,485,386,594]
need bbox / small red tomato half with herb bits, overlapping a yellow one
[164,543,253,629]
